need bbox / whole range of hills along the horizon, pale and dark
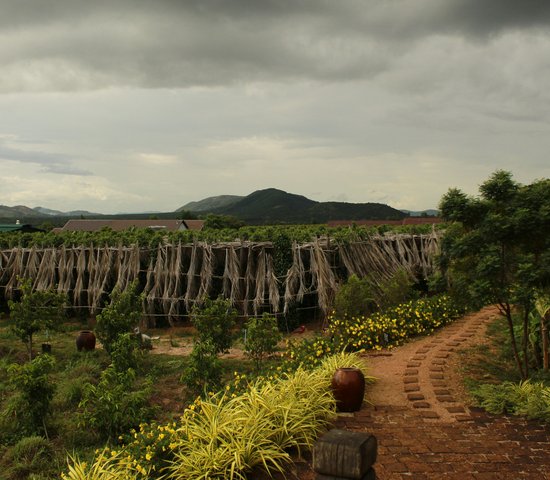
[0,188,437,225]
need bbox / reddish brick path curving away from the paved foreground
[334,308,550,480]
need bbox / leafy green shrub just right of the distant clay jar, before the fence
[95,281,143,355]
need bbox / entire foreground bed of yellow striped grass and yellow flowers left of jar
[71,353,370,480]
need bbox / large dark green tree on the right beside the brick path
[440,170,550,379]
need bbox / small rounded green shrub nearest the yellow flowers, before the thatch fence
[245,313,282,370]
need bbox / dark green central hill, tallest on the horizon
[205,188,407,225]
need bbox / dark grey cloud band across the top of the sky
[0,0,550,91]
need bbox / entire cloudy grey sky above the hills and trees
[0,0,550,213]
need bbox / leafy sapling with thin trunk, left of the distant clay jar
[8,279,65,360]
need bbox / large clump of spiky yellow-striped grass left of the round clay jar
[168,354,354,479]
